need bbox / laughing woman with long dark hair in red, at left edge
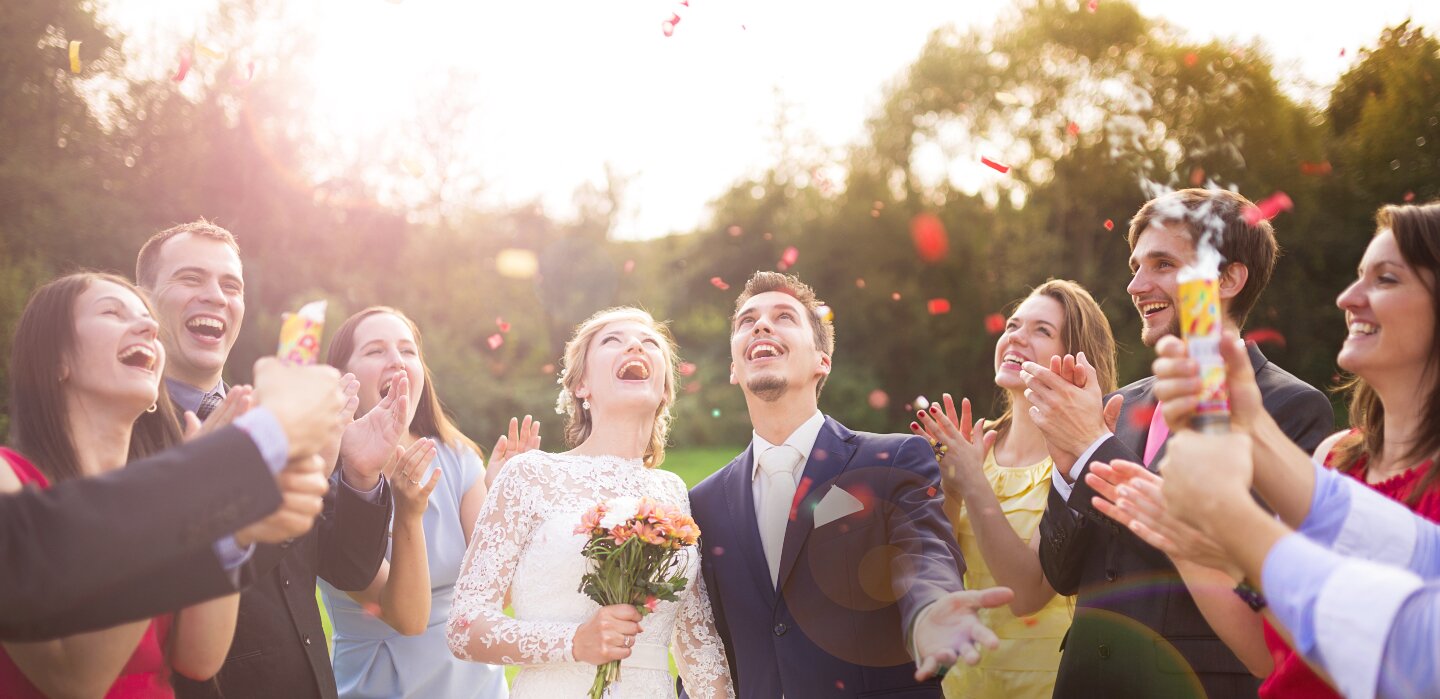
[0,274,243,698]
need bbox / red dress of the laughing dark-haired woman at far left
[0,447,176,699]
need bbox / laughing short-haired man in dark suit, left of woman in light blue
[135,219,393,699]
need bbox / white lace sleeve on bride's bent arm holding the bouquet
[446,454,579,664]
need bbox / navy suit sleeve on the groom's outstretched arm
[886,437,965,628]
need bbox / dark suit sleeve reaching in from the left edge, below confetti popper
[0,427,281,641]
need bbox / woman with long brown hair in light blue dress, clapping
[320,306,540,699]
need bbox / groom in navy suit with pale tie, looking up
[690,272,1011,699]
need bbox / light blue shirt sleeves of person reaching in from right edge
[1261,464,1440,699]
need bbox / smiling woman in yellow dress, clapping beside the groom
[910,280,1115,699]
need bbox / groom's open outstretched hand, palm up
[914,588,1015,682]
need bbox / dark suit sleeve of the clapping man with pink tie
[1040,437,1140,595]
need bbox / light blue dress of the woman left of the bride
[320,445,508,699]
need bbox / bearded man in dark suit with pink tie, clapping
[1024,189,1333,698]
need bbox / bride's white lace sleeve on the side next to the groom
[670,476,734,699]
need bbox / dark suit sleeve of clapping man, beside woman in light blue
[315,476,392,591]
